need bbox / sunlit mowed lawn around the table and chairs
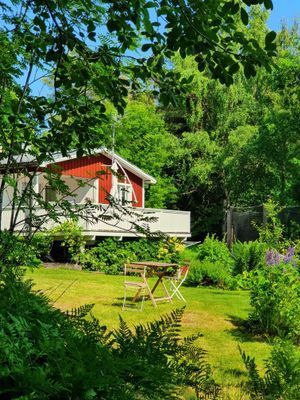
[26,268,270,400]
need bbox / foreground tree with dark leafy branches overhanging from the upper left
[0,0,275,234]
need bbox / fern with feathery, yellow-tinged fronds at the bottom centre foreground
[110,308,219,400]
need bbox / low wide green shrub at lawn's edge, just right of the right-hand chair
[187,260,236,289]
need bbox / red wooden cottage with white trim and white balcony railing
[3,148,190,240]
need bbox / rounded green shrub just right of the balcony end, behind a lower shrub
[198,235,233,270]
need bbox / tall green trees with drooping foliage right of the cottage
[166,12,300,234]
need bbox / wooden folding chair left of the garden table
[122,264,151,311]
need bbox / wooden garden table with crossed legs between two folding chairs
[131,261,178,307]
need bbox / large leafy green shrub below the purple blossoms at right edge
[249,263,300,342]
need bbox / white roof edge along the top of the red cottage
[41,147,156,183]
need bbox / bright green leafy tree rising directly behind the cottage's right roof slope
[115,95,176,208]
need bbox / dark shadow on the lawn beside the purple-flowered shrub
[227,315,267,343]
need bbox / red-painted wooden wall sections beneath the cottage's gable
[51,154,143,207]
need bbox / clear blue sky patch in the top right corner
[268,0,300,31]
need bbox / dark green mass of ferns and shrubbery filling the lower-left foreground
[0,279,217,400]
